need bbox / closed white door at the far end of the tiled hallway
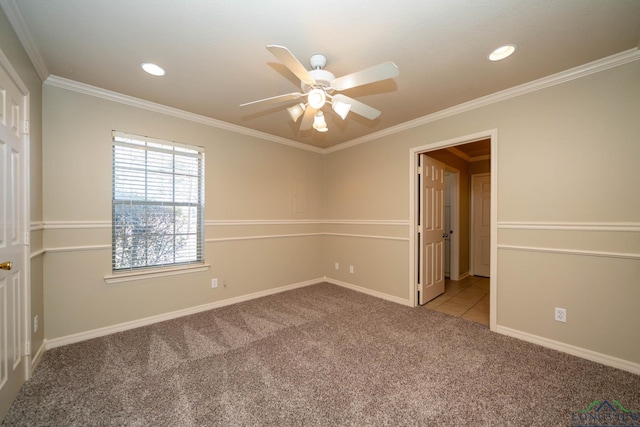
[471,174,491,277]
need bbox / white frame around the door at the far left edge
[0,49,32,381]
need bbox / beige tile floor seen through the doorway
[424,276,489,326]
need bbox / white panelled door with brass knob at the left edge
[0,58,28,419]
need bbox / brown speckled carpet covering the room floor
[2,283,640,426]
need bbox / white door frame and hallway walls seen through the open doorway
[409,130,498,330]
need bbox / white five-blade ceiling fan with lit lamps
[240,45,399,132]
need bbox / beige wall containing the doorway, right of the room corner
[324,61,640,364]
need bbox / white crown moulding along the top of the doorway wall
[324,48,640,154]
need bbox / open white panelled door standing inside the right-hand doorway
[418,154,445,305]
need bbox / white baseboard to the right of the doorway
[496,326,640,375]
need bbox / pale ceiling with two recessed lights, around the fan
[5,0,640,148]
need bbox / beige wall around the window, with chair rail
[43,84,323,339]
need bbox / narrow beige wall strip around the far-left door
[0,9,45,360]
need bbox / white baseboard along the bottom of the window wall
[46,278,324,350]
